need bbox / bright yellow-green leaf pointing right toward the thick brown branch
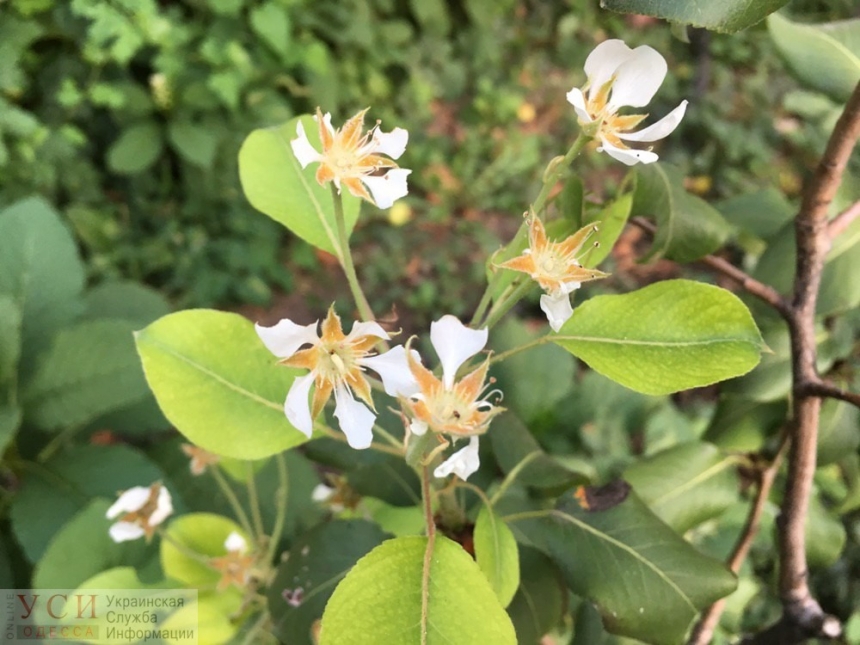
[552,280,763,395]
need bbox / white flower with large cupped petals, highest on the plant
[567,40,687,166]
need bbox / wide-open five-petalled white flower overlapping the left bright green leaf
[256,307,417,449]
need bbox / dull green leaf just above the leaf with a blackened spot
[624,442,740,533]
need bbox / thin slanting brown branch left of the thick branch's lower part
[687,432,788,645]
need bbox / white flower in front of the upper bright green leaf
[290,108,412,208]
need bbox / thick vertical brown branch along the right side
[747,78,860,645]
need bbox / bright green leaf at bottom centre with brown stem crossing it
[320,534,517,645]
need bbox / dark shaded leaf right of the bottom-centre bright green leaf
[508,546,568,645]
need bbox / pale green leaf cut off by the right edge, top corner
[767,14,860,102]
